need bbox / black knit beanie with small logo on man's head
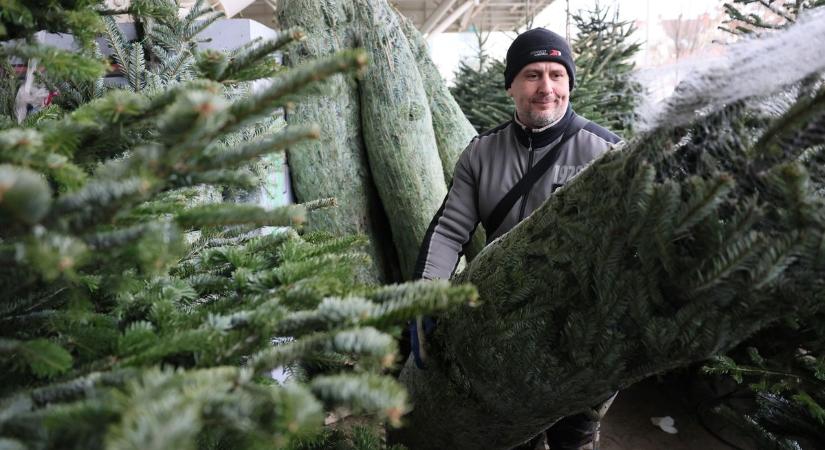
[504,28,576,91]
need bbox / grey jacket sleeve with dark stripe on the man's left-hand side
[413,141,479,280]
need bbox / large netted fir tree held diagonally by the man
[390,12,825,449]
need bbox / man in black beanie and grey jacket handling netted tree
[411,28,620,450]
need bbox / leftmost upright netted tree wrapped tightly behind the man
[278,0,400,281]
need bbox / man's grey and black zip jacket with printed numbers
[414,108,621,279]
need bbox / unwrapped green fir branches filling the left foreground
[0,0,474,449]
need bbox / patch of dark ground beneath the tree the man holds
[599,380,753,450]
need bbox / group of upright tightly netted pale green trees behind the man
[278,0,483,281]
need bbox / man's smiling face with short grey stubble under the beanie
[507,61,570,128]
